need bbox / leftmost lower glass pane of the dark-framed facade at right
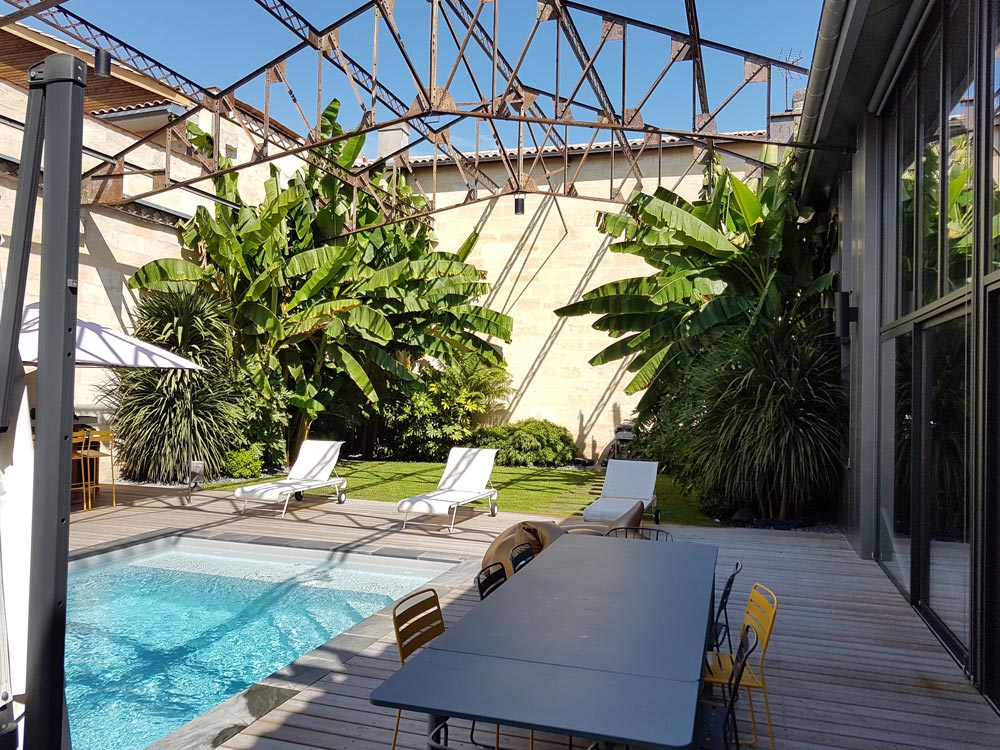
[878,333,913,591]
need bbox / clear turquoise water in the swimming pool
[66,545,440,750]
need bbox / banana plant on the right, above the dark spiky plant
[555,152,833,418]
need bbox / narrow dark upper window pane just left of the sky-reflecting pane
[918,34,941,305]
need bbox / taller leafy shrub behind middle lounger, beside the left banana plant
[377,354,511,461]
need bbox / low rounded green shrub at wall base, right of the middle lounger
[471,419,576,466]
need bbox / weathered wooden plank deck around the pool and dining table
[71,487,1000,750]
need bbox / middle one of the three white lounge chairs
[396,448,500,532]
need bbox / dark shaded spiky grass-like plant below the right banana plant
[636,324,847,519]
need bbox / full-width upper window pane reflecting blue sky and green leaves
[945,0,976,292]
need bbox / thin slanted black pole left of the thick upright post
[0,67,45,432]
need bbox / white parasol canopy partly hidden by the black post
[18,303,205,370]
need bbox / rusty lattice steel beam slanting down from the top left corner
[7,0,207,103]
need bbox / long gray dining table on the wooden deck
[371,534,718,748]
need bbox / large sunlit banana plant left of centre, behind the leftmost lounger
[129,100,513,457]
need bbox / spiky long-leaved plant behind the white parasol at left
[101,291,245,482]
